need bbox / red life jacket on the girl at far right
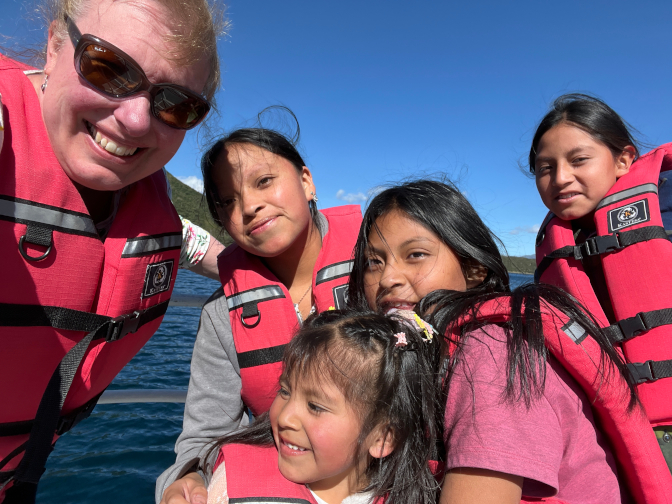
[535,144,672,425]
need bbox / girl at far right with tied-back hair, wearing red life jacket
[529,94,672,472]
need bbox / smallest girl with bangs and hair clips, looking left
[204,310,441,504]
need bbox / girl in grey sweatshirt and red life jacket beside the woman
[156,123,361,503]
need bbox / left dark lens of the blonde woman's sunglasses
[79,43,142,95]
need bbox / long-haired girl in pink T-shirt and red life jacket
[349,180,665,504]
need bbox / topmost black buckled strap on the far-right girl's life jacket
[534,226,669,283]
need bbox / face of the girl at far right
[534,123,634,220]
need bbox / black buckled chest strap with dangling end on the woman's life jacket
[0,301,168,487]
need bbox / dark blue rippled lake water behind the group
[37,271,532,504]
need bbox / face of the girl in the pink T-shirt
[364,210,472,311]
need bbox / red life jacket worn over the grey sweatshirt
[218,205,362,416]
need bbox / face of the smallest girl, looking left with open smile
[270,377,368,496]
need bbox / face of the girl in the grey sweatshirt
[212,144,315,257]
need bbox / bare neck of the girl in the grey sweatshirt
[263,221,322,290]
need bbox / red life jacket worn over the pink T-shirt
[455,298,672,504]
